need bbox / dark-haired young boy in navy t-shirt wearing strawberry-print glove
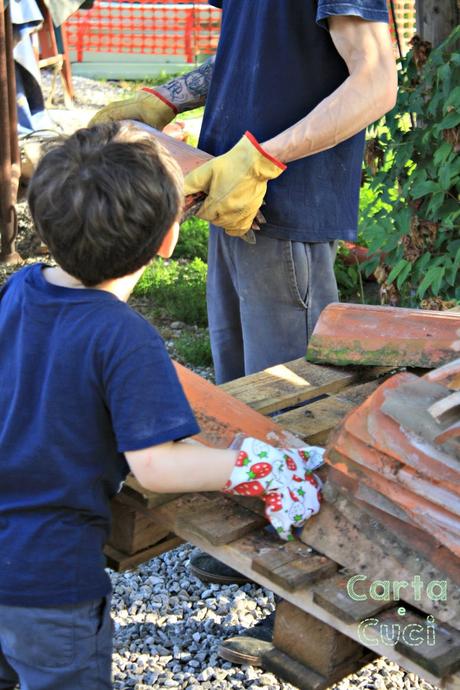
[0,123,319,690]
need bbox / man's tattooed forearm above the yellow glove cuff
[156,55,215,113]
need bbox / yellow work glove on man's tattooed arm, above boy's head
[89,87,177,130]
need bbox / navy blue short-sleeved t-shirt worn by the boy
[0,264,199,606]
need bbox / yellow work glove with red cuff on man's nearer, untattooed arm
[184,132,286,237]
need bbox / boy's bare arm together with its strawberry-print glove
[125,438,323,539]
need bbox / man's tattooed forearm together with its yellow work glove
[89,55,215,129]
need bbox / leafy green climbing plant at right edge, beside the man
[361,27,460,306]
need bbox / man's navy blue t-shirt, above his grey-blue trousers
[199,0,388,242]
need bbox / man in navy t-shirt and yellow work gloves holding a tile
[92,0,397,660]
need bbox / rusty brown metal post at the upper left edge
[0,0,20,263]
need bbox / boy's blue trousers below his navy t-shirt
[0,597,113,690]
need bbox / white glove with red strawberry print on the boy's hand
[223,438,324,541]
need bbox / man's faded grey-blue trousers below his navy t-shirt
[207,226,338,383]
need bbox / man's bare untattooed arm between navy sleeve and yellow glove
[261,17,397,163]
